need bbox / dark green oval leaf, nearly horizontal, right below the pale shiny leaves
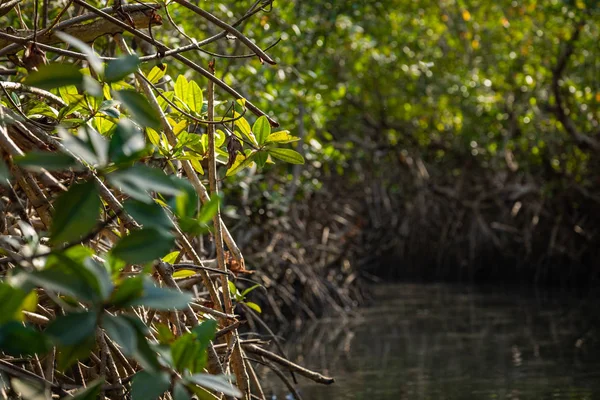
[112,228,175,264]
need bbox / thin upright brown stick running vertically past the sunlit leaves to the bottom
[206,60,250,399]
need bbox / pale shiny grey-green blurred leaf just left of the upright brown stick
[106,165,181,204]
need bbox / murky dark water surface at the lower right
[265,285,600,400]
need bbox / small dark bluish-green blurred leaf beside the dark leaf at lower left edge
[45,311,98,346]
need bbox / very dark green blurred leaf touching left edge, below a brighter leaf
[0,321,52,357]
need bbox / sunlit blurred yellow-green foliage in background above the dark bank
[159,0,600,191]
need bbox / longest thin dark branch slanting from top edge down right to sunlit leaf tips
[74,0,279,127]
